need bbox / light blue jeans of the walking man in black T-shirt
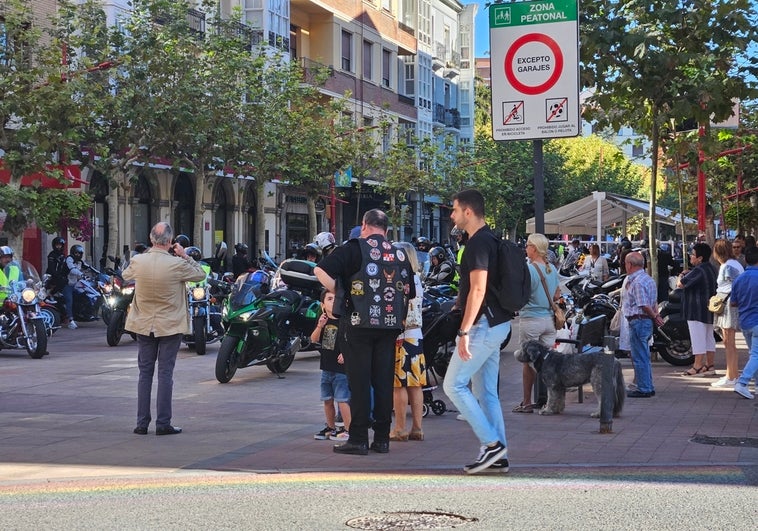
[443,316,511,446]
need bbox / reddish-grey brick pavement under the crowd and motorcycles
[0,323,758,480]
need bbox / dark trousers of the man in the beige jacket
[137,334,182,428]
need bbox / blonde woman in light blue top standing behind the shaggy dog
[513,234,561,413]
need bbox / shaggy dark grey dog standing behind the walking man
[513,340,626,418]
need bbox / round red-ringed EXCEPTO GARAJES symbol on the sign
[503,33,563,96]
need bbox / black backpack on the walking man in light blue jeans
[490,232,532,313]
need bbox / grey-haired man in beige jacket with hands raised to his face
[123,222,205,435]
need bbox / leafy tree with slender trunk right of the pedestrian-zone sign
[580,0,756,282]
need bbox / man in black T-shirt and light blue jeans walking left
[444,190,513,474]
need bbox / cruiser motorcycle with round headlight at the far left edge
[0,262,47,359]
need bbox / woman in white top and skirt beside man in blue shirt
[711,240,745,389]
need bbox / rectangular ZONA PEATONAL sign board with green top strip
[490,0,581,140]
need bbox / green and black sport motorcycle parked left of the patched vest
[216,260,321,383]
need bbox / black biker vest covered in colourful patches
[345,235,413,330]
